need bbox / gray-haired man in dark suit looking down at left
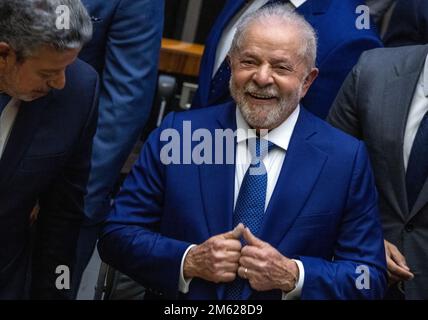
[0,0,98,299]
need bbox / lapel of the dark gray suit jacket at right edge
[382,49,428,220]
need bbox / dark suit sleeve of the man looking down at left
[31,76,99,299]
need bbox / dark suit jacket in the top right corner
[383,0,428,47]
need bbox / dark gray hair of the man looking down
[0,0,92,61]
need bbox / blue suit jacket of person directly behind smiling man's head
[192,0,382,119]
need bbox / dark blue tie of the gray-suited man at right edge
[406,112,428,212]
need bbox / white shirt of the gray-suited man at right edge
[403,52,428,170]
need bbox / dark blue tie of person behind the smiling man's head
[208,0,289,105]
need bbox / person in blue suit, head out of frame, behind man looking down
[73,0,164,294]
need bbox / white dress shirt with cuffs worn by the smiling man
[179,106,305,300]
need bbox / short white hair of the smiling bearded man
[229,4,317,69]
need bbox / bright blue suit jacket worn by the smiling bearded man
[98,103,386,299]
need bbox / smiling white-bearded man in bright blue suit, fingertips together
[98,6,386,299]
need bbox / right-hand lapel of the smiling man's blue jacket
[243,108,327,299]
